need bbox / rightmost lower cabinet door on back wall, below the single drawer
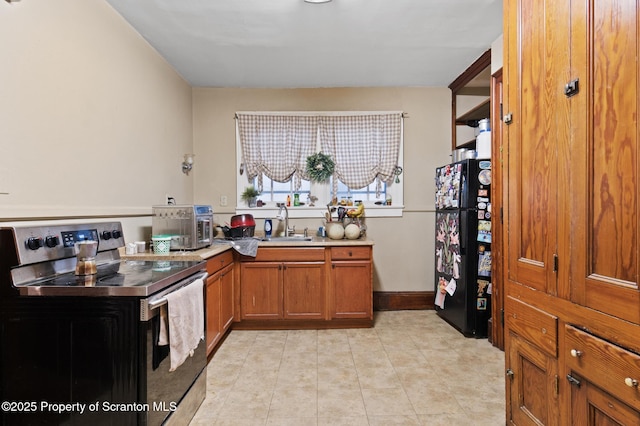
[331,261,373,319]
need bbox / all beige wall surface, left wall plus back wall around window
[0,0,460,291]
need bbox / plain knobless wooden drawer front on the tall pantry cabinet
[505,297,558,358]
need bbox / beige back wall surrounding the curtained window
[193,88,451,291]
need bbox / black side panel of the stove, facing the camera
[0,297,141,426]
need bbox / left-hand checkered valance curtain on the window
[236,113,318,192]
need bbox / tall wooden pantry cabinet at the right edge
[501,0,640,425]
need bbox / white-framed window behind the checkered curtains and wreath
[236,111,403,218]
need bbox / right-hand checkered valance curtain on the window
[318,112,402,197]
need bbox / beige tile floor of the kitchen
[191,311,505,426]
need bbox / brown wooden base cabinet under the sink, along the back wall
[236,245,373,328]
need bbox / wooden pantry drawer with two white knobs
[564,325,640,410]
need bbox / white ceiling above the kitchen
[107,0,502,88]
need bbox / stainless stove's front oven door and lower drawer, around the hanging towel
[140,272,207,425]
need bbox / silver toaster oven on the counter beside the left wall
[151,204,213,250]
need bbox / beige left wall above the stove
[0,0,193,236]
